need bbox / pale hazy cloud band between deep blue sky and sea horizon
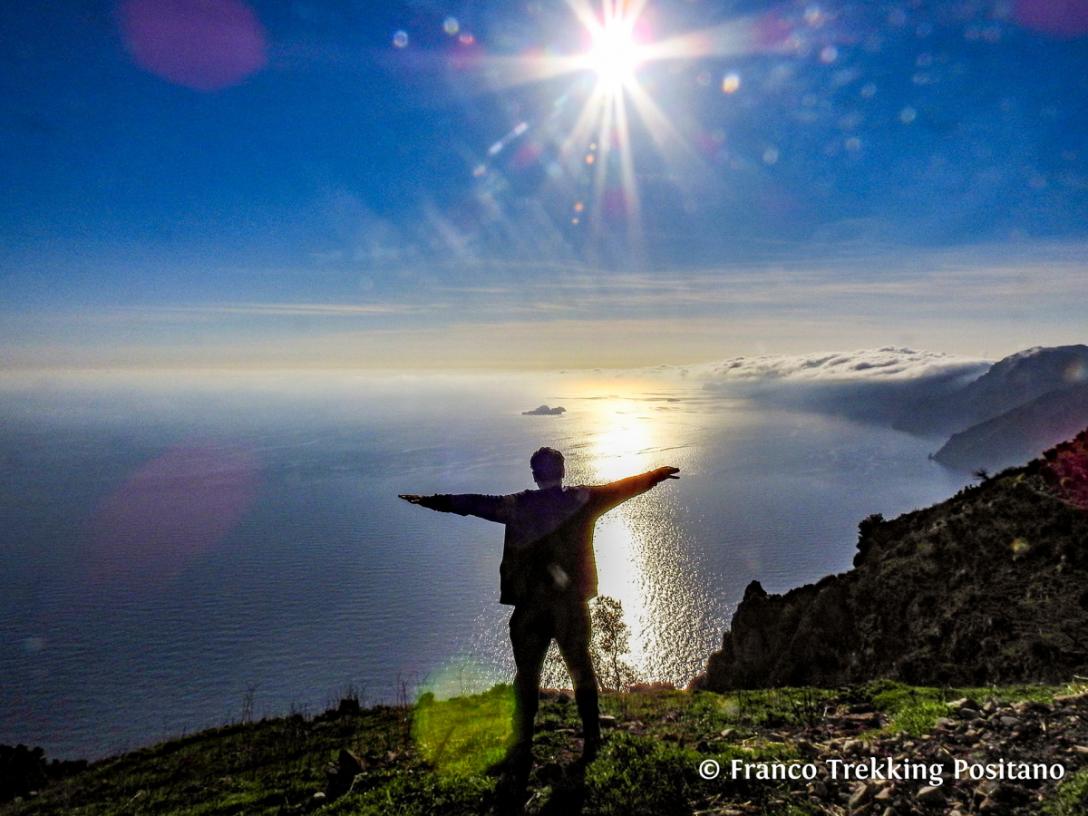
[0,246,1088,368]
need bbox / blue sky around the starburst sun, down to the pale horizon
[0,0,1088,367]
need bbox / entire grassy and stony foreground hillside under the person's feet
[0,681,1088,816]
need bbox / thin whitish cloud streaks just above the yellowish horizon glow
[57,265,1088,322]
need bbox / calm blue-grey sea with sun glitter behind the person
[0,371,963,757]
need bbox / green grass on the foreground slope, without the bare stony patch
[0,681,1088,816]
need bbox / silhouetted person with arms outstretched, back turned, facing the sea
[400,447,680,776]
